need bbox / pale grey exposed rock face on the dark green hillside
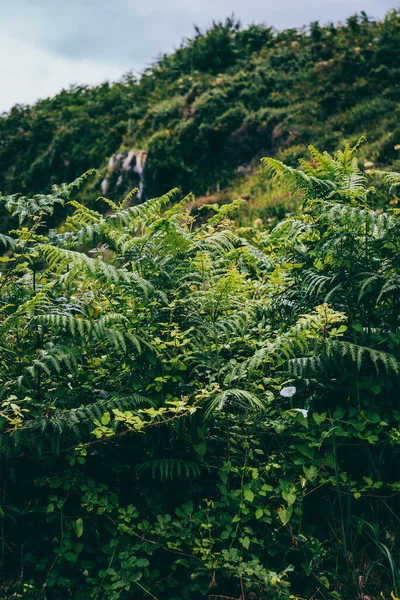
[100,148,147,202]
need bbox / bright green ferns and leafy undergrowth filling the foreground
[0,147,400,600]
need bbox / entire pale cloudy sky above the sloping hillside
[0,0,396,113]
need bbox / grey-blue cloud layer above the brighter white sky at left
[0,0,391,65]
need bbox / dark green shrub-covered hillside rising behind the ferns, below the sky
[0,11,400,232]
